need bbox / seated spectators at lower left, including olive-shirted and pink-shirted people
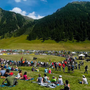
[0,67,31,86]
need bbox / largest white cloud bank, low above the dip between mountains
[10,7,44,19]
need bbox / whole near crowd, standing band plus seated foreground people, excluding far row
[0,56,88,90]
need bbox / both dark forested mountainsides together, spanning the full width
[0,2,90,42]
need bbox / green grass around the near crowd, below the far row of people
[0,55,90,90]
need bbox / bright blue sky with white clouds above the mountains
[0,0,90,19]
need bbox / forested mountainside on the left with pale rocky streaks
[0,8,33,38]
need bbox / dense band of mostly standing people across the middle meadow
[0,56,85,73]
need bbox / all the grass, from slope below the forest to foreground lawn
[0,35,90,90]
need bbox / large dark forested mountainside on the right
[27,2,90,42]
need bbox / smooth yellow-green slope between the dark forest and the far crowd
[0,35,90,51]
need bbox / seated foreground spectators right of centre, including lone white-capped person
[37,74,88,90]
